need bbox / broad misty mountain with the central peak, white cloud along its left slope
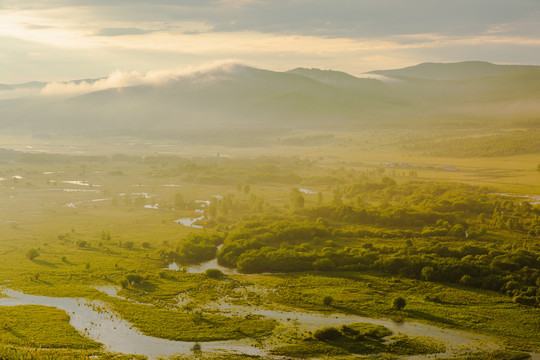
[0,66,399,131]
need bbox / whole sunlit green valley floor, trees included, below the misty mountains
[0,130,540,359]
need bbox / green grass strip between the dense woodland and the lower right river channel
[240,272,540,349]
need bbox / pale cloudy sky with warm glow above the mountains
[0,0,540,84]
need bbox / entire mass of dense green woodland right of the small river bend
[214,179,540,305]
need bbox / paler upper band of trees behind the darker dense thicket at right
[336,178,540,237]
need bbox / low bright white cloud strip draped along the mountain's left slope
[40,60,241,96]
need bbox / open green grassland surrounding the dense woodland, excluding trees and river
[0,131,540,359]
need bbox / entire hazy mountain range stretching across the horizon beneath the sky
[0,62,540,136]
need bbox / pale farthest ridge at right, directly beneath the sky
[368,61,540,80]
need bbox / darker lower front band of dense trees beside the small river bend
[218,215,540,305]
